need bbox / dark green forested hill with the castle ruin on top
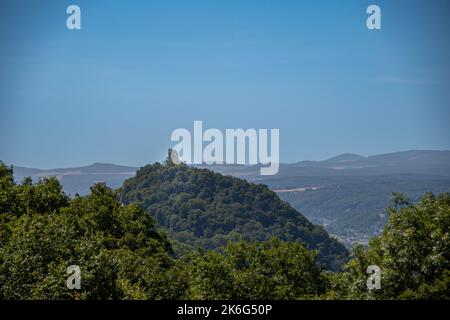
[121,162,348,269]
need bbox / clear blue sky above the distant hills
[0,0,450,168]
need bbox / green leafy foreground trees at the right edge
[326,193,450,299]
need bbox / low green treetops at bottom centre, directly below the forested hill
[182,238,326,299]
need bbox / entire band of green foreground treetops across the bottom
[0,162,450,299]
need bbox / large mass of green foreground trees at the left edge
[0,163,186,299]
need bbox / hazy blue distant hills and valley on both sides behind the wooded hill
[8,150,450,245]
